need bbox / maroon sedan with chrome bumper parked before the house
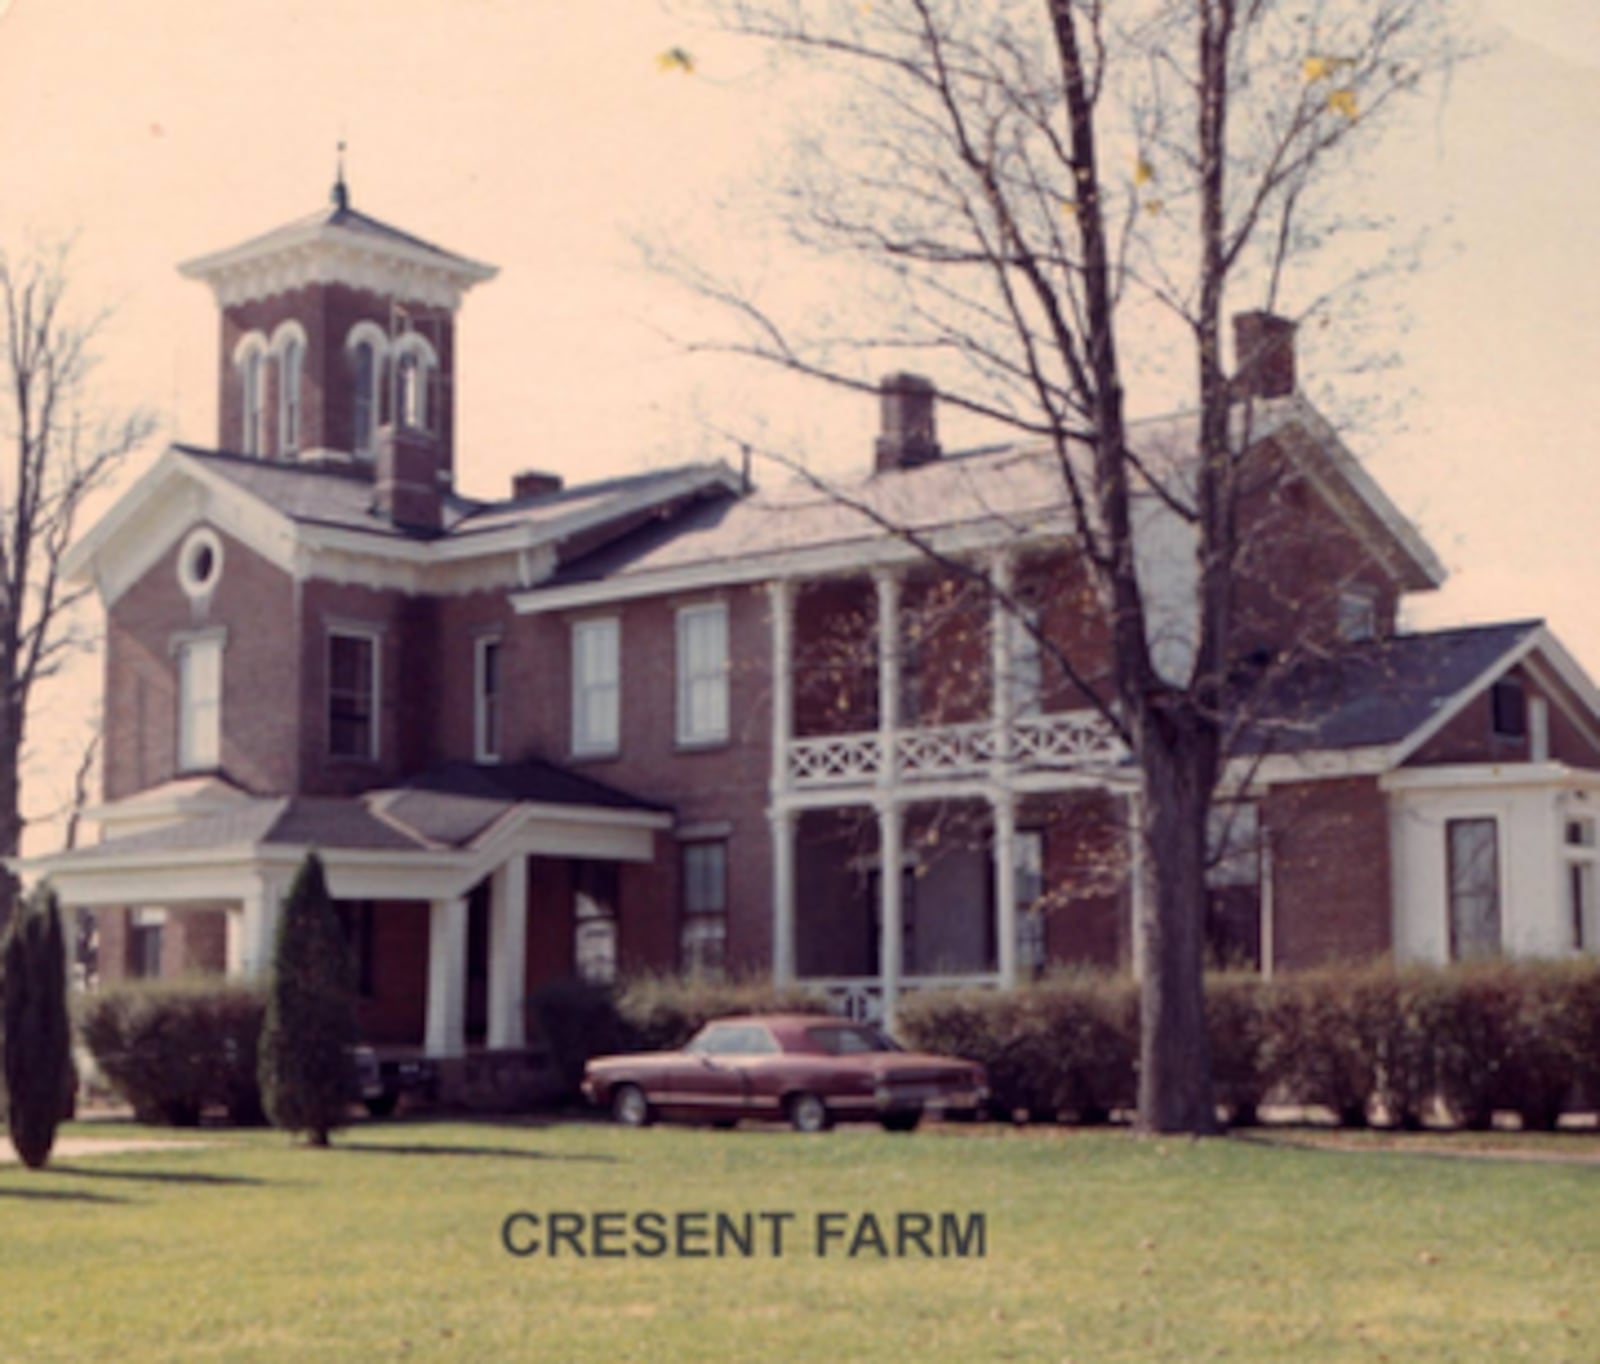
[584,1013,989,1132]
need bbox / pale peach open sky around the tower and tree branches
[0,0,1600,838]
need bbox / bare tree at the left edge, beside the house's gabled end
[0,247,155,924]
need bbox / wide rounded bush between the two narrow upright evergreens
[78,978,266,1127]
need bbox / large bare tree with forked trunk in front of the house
[656,0,1456,1132]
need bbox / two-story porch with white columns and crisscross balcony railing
[768,551,1138,1017]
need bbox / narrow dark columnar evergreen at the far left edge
[0,885,77,1170]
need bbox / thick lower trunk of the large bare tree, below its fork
[1138,716,1218,1133]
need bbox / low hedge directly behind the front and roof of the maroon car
[528,975,827,1097]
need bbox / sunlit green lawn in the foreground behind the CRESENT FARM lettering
[0,1124,1600,1364]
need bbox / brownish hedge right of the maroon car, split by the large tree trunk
[901,961,1600,1129]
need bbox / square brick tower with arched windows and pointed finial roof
[179,173,496,487]
